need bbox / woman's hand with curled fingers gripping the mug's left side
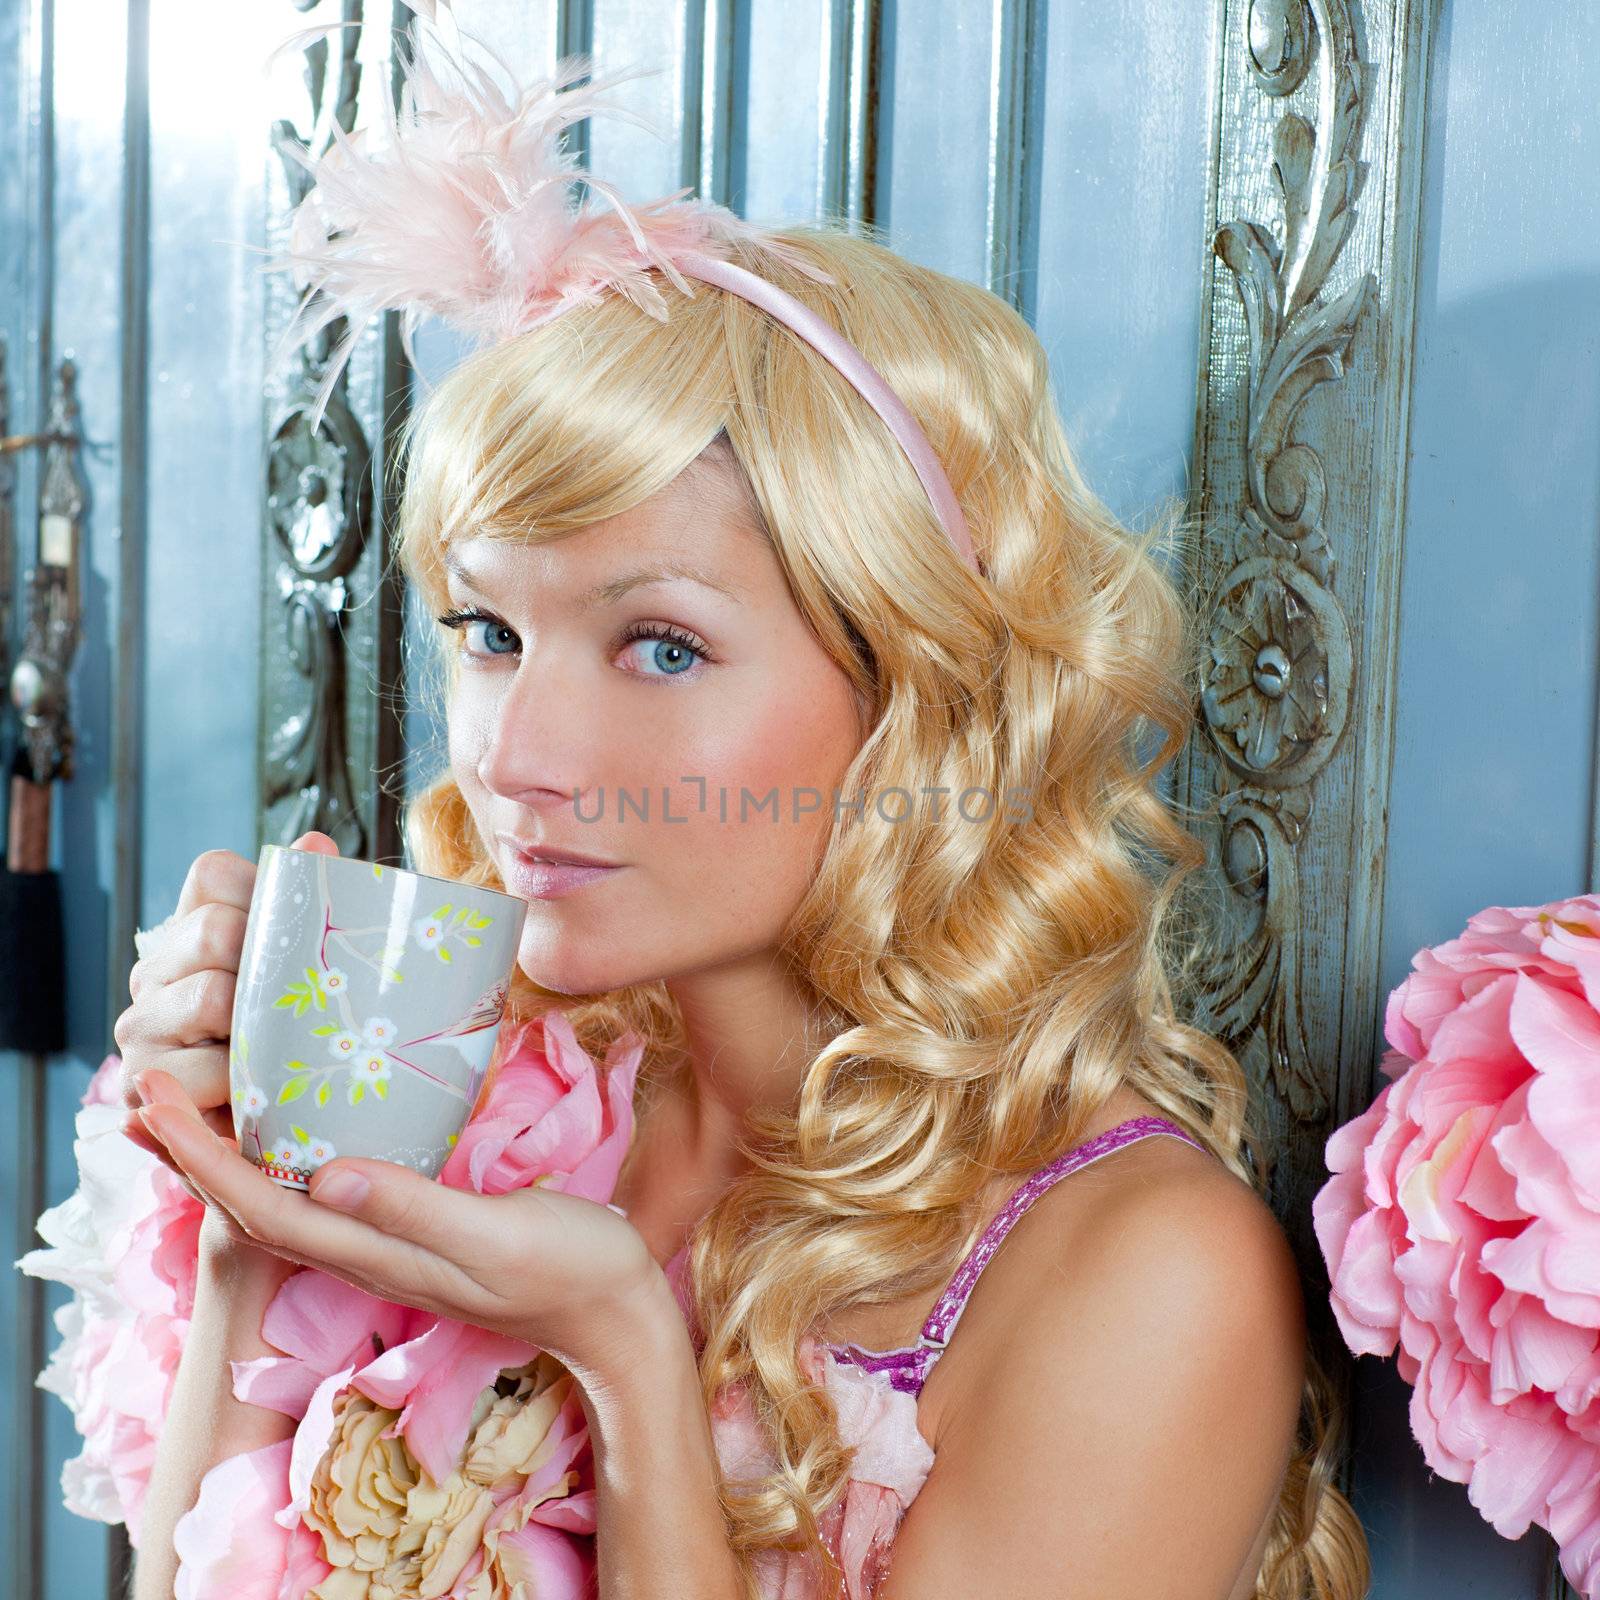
[112,834,339,1200]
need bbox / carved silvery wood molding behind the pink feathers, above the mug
[258,0,408,861]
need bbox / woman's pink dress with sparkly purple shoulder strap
[666,1117,1205,1600]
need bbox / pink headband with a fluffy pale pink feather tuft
[272,14,981,573]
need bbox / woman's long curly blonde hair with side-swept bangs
[384,224,1368,1600]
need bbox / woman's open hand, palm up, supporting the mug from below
[128,1067,670,1381]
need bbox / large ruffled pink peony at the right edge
[1312,894,1600,1600]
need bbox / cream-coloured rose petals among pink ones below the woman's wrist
[304,1354,578,1600]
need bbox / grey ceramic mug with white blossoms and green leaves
[229,845,528,1189]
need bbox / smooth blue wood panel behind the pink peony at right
[1355,0,1600,1600]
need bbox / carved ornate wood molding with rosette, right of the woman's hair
[1176,0,1437,1478]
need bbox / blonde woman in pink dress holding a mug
[117,37,1366,1600]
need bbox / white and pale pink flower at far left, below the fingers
[14,1056,205,1549]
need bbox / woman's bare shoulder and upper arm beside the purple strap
[882,1138,1304,1600]
